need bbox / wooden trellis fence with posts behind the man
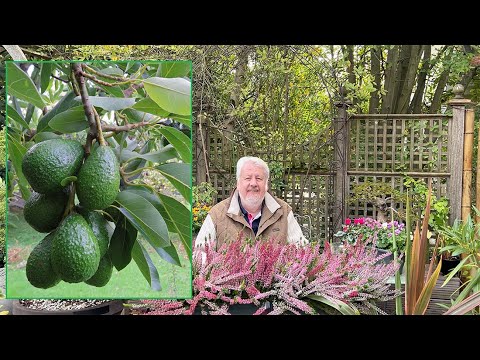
[193,91,470,240]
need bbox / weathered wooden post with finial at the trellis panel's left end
[332,87,351,232]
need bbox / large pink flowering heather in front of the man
[137,233,400,315]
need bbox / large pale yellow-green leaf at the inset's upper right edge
[144,77,192,115]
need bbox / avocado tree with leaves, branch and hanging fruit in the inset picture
[6,61,192,290]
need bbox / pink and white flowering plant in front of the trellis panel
[334,217,407,252]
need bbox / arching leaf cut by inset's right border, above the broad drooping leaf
[125,186,192,257]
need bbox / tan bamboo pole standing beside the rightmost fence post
[462,109,478,221]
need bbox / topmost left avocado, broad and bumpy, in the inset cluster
[22,139,84,194]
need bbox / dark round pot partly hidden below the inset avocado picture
[12,300,123,315]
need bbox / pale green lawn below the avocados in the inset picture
[6,213,192,299]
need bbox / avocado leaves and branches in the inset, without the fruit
[7,60,192,290]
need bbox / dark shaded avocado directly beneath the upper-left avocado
[23,191,68,233]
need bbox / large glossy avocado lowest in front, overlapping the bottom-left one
[51,213,100,283]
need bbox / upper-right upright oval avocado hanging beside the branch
[76,146,120,210]
